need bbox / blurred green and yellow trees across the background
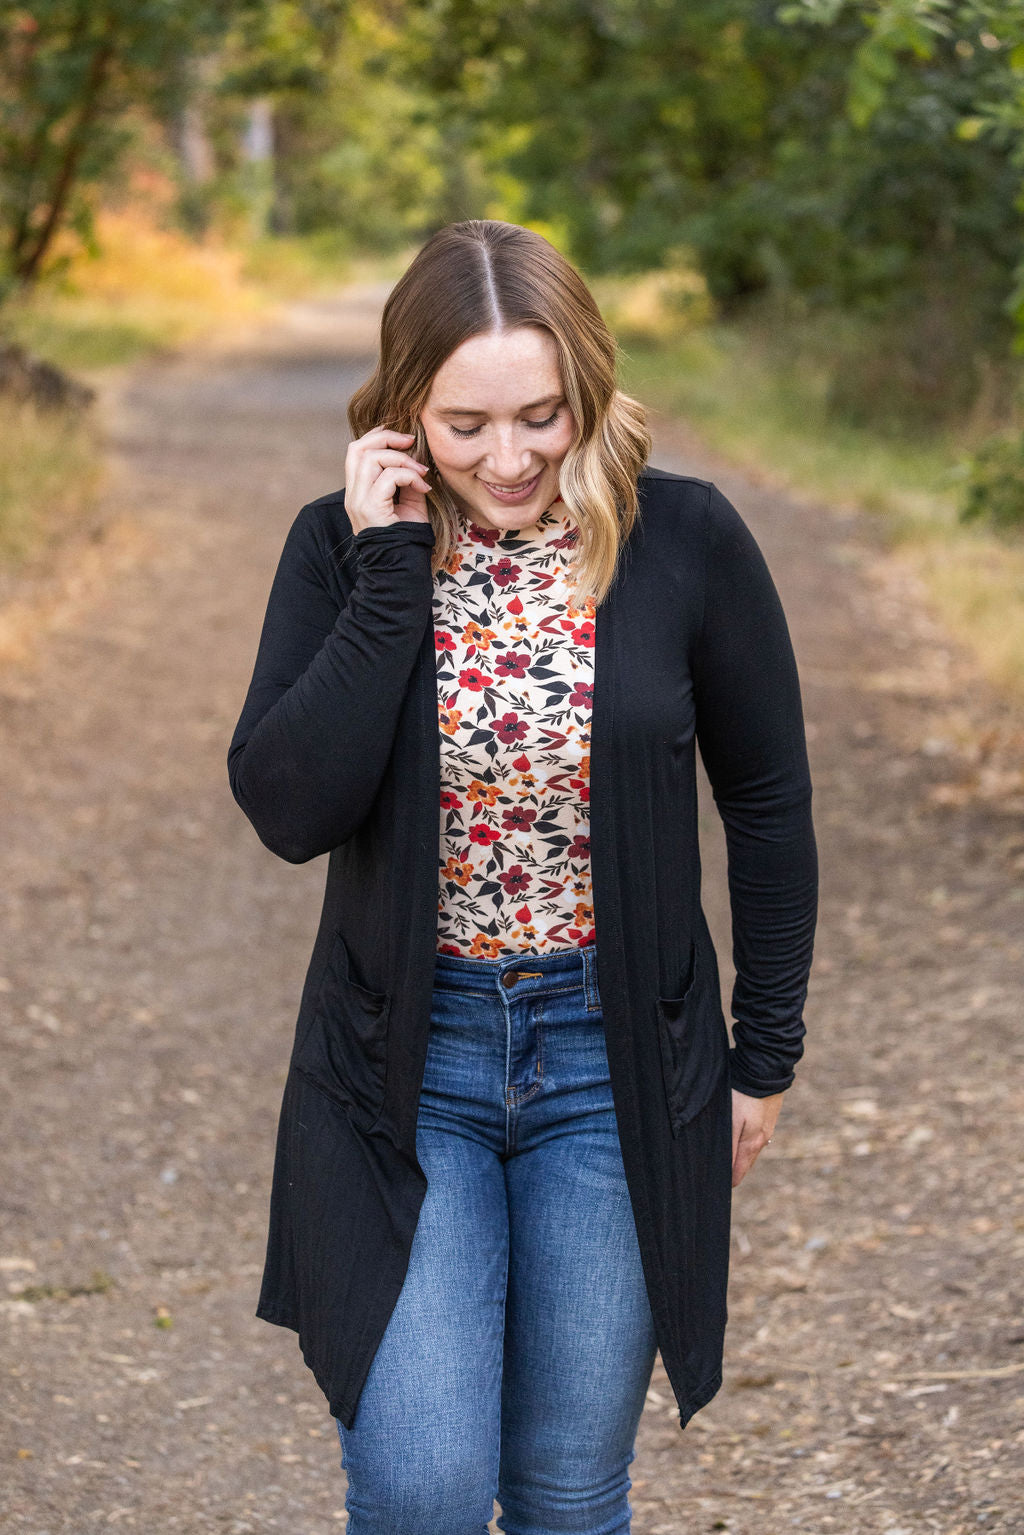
[0,0,1024,522]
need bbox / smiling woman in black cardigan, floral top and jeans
[229,220,817,1535]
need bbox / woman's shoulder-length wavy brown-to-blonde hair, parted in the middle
[348,218,651,605]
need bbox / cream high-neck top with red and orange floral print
[433,496,596,959]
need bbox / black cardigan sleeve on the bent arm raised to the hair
[227,505,434,863]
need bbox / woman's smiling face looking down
[421,325,576,530]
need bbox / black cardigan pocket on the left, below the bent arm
[292,933,391,1130]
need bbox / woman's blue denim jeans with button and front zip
[336,946,657,1535]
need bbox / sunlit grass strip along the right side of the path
[620,322,1024,701]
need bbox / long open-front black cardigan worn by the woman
[229,467,817,1424]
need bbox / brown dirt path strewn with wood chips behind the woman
[0,293,1024,1535]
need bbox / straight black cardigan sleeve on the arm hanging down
[691,485,818,1098]
